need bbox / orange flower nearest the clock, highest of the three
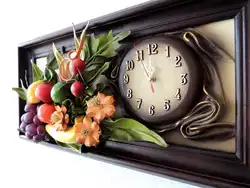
[86,92,115,124]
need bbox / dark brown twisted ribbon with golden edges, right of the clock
[156,30,235,139]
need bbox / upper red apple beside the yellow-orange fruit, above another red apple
[35,83,53,103]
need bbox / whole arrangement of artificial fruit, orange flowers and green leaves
[13,21,167,152]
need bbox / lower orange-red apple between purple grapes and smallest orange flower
[37,104,56,123]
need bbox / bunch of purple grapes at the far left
[19,104,45,142]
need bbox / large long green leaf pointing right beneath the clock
[103,118,168,147]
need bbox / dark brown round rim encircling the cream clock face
[118,35,203,125]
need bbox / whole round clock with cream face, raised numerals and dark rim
[119,38,202,124]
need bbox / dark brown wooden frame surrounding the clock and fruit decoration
[18,0,250,187]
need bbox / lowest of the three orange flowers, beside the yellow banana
[74,116,101,147]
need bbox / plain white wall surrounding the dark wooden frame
[0,0,203,188]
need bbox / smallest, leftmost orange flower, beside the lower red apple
[50,105,69,131]
